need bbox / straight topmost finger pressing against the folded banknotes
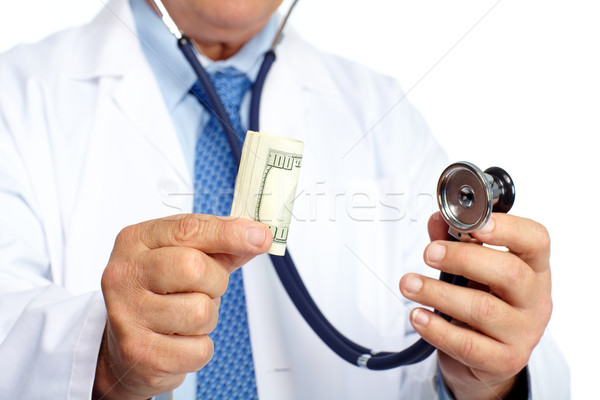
[117,214,272,255]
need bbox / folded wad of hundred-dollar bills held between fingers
[231,131,304,256]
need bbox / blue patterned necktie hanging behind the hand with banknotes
[192,68,257,400]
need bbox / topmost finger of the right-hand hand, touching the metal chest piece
[472,213,550,272]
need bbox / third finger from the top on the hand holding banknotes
[142,293,219,336]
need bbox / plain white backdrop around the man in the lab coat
[0,0,600,400]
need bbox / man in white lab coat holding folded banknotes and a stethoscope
[0,0,568,399]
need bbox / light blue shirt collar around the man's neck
[129,0,278,110]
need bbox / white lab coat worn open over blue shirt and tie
[0,0,568,399]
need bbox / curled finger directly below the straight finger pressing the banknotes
[141,247,230,299]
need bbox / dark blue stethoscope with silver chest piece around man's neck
[153,0,514,370]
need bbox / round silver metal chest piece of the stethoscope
[437,162,515,241]
